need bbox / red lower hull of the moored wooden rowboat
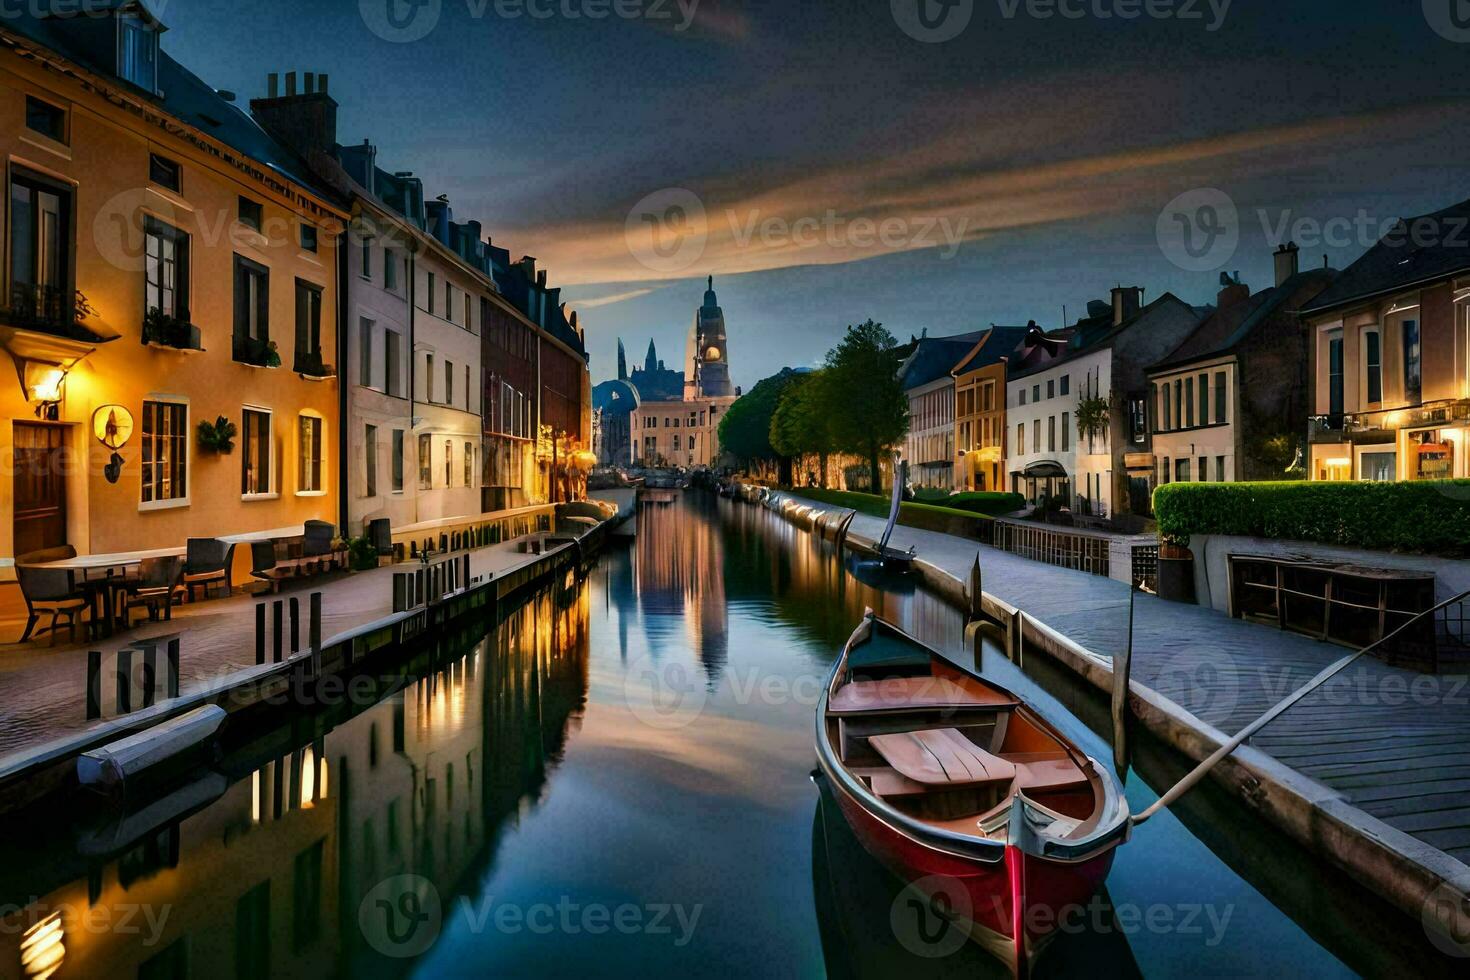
[835,789,1117,973]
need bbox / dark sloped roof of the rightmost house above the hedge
[1302,201,1470,313]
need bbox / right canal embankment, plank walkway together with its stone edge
[745,494,1470,936]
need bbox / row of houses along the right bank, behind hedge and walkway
[901,213,1470,525]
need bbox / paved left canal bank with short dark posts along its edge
[0,513,626,811]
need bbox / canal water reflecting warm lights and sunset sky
[0,494,1421,980]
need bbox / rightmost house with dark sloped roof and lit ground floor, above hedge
[1302,201,1470,480]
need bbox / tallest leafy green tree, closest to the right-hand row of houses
[822,320,908,494]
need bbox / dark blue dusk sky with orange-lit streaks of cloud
[150,0,1470,388]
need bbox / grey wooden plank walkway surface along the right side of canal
[803,501,1470,862]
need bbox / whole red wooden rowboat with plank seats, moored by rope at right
[816,610,1130,976]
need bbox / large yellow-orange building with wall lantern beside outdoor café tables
[0,1,347,577]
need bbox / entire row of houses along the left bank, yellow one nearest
[0,0,591,577]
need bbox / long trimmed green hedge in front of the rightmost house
[1154,480,1470,557]
